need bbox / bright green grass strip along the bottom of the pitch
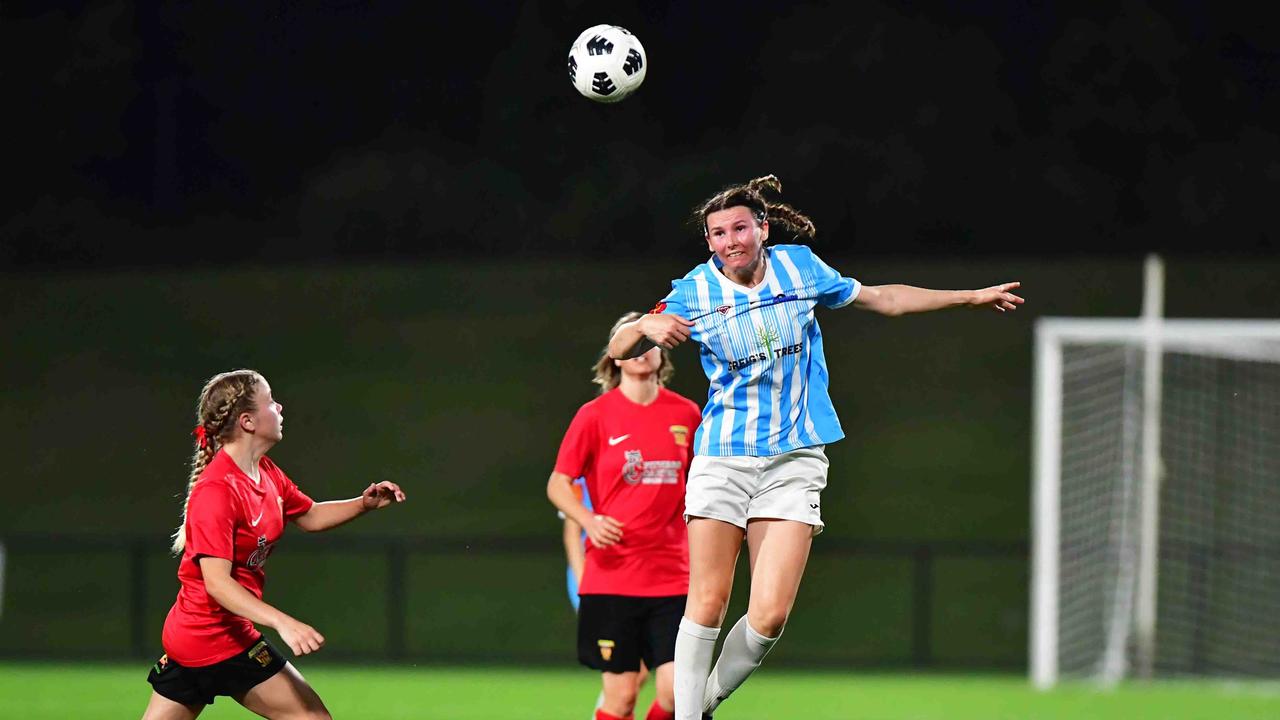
[0,662,1280,720]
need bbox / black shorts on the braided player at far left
[147,635,288,705]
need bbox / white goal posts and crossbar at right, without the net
[1029,313,1280,689]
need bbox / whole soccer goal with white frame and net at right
[1030,318,1280,687]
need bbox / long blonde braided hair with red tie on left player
[172,370,262,555]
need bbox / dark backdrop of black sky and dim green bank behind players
[0,1,1280,667]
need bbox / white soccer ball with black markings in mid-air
[568,24,649,102]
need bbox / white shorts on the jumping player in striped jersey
[685,445,827,534]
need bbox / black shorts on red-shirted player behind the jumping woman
[577,594,686,673]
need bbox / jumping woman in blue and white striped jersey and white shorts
[609,176,1023,720]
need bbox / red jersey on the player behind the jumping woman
[556,388,701,597]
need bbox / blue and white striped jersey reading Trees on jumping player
[655,245,861,456]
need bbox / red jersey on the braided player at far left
[161,451,314,667]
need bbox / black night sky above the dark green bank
[0,0,1280,269]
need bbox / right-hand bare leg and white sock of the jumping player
[703,519,813,714]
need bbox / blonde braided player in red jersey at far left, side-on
[142,370,404,720]
